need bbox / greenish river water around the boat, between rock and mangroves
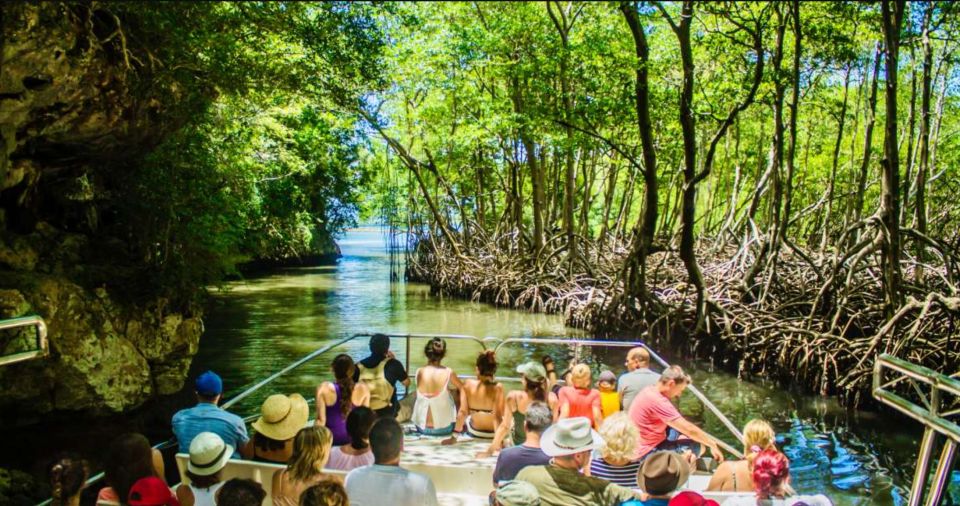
[191,229,960,504]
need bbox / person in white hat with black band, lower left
[177,432,233,506]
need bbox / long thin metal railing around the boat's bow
[37,333,743,506]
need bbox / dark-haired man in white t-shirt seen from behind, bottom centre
[346,418,437,506]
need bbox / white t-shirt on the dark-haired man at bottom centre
[346,464,437,506]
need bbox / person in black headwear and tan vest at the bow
[353,334,410,418]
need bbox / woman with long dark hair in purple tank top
[314,354,370,446]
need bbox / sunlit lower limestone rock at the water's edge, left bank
[0,275,203,413]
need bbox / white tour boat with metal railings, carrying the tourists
[0,317,960,506]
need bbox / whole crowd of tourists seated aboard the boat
[51,334,830,506]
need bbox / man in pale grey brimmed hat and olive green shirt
[517,417,639,506]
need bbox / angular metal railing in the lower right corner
[873,354,960,506]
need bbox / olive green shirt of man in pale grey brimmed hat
[516,466,640,506]
